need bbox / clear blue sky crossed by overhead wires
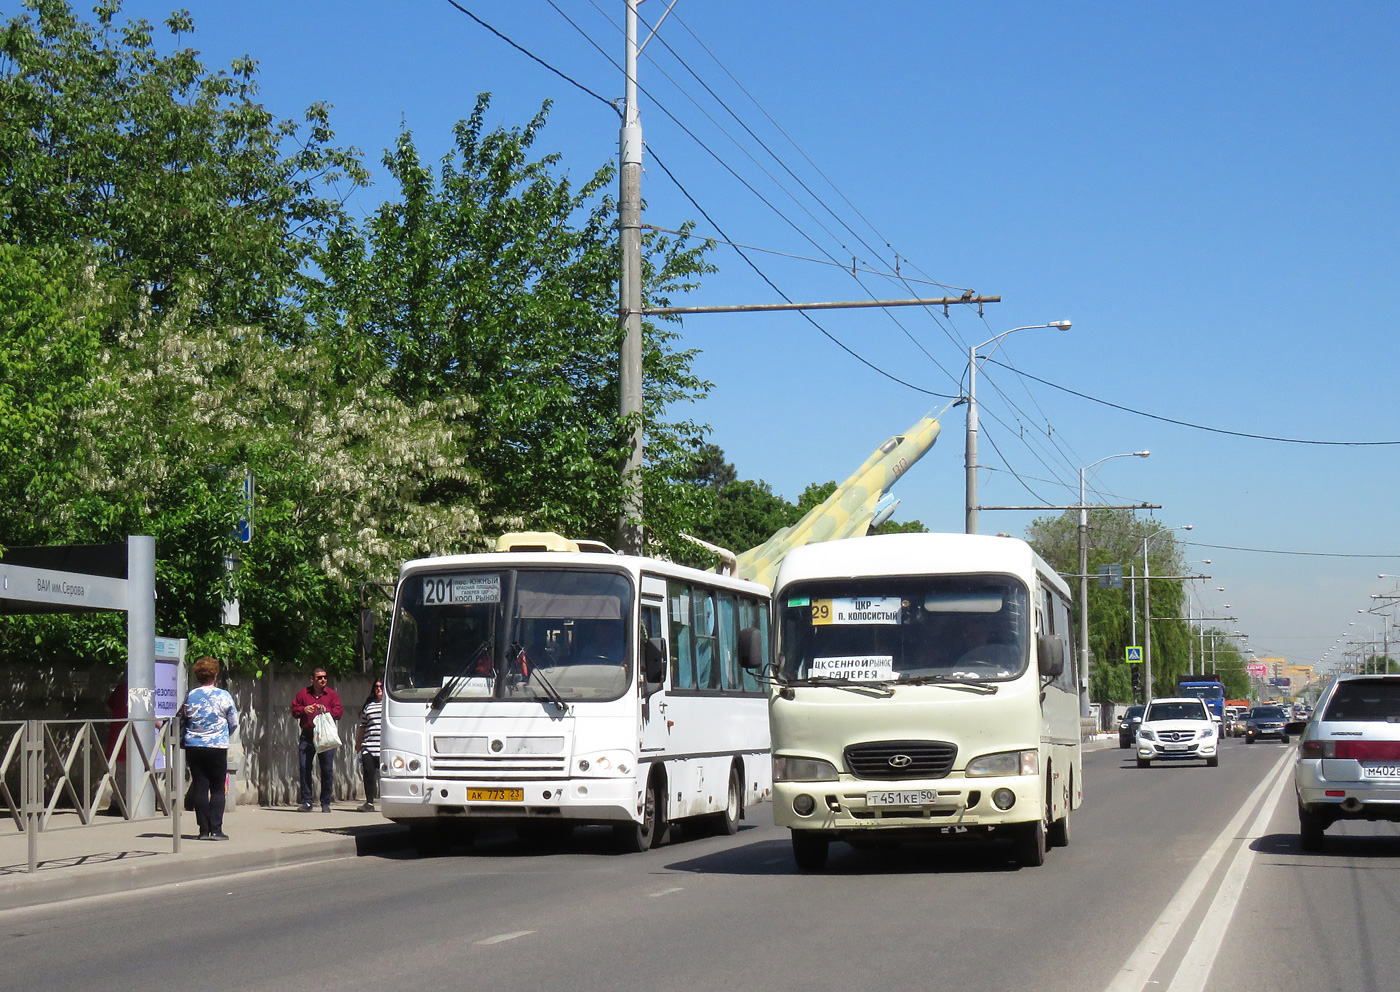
[112,0,1400,674]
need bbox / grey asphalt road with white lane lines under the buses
[0,742,1400,992]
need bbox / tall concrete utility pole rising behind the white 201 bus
[617,0,645,554]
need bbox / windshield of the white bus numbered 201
[388,568,631,701]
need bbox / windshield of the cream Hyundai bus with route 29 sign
[778,575,1029,683]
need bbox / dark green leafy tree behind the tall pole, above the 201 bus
[314,95,711,554]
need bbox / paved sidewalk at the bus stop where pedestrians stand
[0,802,409,911]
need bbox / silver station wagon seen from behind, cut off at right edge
[1294,674,1400,851]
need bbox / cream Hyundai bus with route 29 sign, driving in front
[769,534,1082,870]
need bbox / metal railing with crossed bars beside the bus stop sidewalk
[0,718,185,872]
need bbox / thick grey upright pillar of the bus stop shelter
[126,536,155,817]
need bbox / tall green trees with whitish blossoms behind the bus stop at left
[0,0,467,667]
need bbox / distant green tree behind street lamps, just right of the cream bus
[1026,509,1191,704]
